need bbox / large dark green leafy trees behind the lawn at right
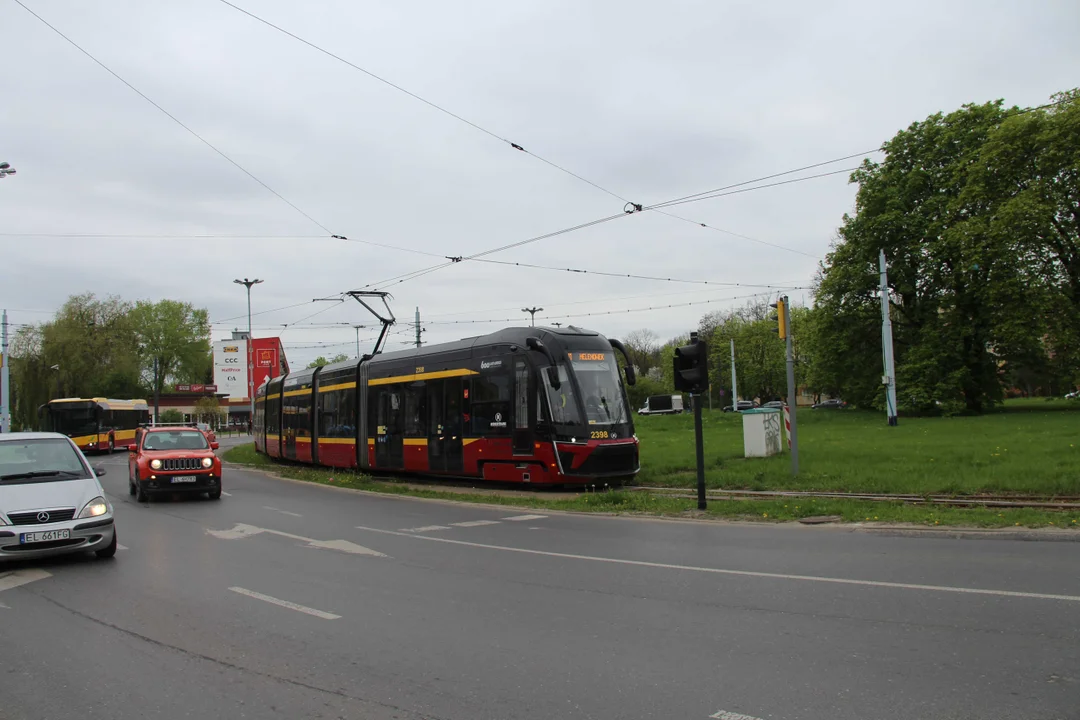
[808,93,1080,412]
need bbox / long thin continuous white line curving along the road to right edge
[356,526,1080,602]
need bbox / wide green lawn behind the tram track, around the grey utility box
[635,398,1080,495]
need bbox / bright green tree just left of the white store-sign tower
[131,300,211,399]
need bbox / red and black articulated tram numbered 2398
[254,327,639,485]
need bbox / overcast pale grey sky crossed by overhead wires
[0,0,1080,366]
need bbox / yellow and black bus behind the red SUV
[38,397,150,452]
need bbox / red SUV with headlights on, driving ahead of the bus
[127,425,221,502]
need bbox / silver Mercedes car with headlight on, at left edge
[0,433,117,560]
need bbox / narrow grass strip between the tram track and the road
[225,445,1080,528]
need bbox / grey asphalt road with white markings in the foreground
[0,444,1080,720]
